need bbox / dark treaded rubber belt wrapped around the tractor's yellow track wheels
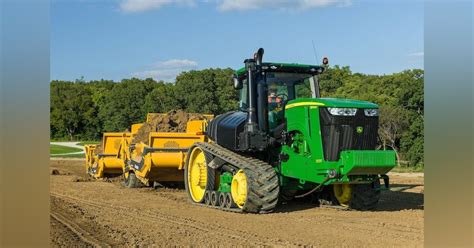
[194,142,280,213]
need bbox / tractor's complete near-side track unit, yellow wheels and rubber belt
[185,143,280,213]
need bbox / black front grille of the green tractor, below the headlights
[319,108,379,161]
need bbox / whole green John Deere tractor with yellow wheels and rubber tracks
[184,48,396,213]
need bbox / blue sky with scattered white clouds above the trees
[51,0,424,81]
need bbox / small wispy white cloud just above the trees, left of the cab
[132,59,198,82]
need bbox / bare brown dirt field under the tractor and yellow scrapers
[50,160,423,247]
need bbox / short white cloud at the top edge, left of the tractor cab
[120,0,195,13]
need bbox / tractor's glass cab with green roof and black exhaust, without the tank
[234,49,327,134]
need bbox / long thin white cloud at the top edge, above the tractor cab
[217,0,351,11]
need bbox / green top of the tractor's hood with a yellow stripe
[286,98,379,109]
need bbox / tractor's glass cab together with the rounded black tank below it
[208,48,327,152]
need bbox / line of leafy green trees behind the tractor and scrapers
[50,66,424,166]
